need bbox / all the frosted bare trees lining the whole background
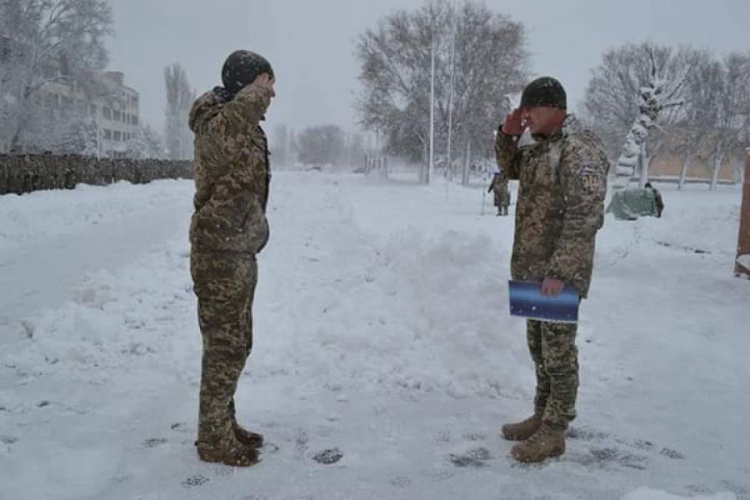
[0,0,750,180]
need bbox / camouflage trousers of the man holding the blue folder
[526,320,578,426]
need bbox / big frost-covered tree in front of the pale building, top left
[0,0,112,149]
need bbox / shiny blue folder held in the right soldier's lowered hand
[508,280,580,323]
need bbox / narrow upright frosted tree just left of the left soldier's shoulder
[164,63,196,160]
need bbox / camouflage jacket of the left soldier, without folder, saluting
[189,85,271,254]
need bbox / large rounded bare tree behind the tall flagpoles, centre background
[357,0,528,184]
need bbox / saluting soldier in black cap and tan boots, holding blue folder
[496,77,609,462]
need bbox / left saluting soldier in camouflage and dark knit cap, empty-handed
[190,51,275,466]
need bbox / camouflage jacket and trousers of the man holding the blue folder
[496,115,609,426]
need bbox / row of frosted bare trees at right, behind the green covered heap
[583,43,750,187]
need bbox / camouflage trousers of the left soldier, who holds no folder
[190,252,258,446]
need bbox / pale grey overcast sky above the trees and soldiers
[108,0,750,135]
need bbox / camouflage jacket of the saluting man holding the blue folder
[495,115,609,297]
